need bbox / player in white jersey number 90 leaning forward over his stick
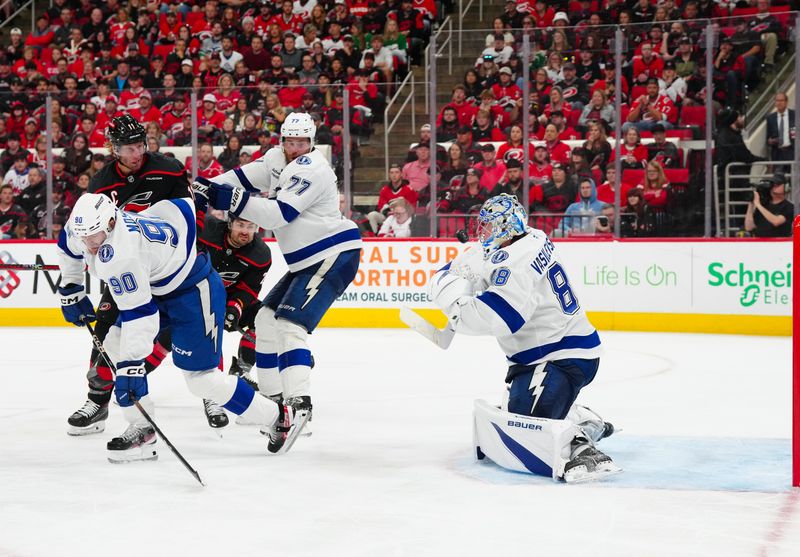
[58,193,307,462]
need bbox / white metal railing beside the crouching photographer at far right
[714,161,800,238]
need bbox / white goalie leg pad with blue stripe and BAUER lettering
[473,399,580,480]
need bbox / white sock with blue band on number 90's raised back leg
[183,369,278,425]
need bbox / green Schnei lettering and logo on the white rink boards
[708,262,792,307]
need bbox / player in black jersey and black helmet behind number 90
[66,114,202,435]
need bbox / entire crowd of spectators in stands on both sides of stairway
[0,0,793,238]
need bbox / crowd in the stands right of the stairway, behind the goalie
[364,0,796,236]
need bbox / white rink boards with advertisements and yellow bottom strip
[0,240,792,335]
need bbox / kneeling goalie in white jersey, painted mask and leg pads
[429,194,621,482]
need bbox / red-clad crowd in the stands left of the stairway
[0,0,451,238]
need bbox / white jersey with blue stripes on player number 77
[213,147,361,271]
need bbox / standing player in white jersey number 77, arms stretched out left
[192,113,361,444]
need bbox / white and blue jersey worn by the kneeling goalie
[444,229,601,365]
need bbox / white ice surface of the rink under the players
[0,328,800,557]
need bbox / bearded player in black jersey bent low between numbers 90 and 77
[198,212,272,394]
